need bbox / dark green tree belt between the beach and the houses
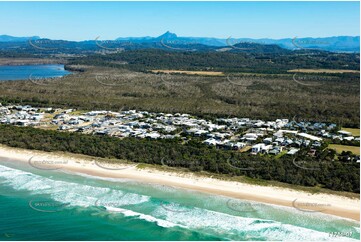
[0,125,360,193]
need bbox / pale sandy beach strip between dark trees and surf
[0,145,360,221]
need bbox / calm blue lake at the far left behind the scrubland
[0,64,71,81]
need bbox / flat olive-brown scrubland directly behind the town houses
[0,66,360,128]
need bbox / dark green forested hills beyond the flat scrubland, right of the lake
[69,49,360,74]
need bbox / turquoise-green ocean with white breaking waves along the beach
[0,158,360,241]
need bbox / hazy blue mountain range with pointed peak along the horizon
[0,31,360,53]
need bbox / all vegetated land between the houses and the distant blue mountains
[0,47,360,128]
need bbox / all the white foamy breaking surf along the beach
[0,165,355,241]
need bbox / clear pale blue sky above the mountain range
[0,2,360,40]
